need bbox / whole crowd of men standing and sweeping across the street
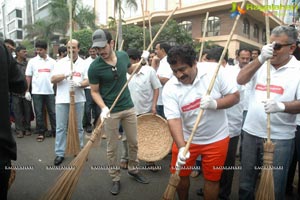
[1,26,300,200]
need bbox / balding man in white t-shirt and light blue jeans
[51,40,88,165]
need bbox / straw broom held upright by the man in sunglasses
[255,2,275,200]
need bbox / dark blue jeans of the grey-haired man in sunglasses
[239,132,294,200]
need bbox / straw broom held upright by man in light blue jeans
[66,0,80,155]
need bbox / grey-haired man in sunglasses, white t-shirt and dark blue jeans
[237,26,300,200]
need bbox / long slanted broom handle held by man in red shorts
[180,0,246,160]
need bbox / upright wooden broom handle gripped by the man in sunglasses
[265,0,271,142]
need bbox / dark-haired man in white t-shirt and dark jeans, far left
[25,41,56,142]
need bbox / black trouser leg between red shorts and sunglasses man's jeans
[219,136,239,200]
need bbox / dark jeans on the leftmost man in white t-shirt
[32,94,56,135]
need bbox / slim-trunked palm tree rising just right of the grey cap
[114,0,137,48]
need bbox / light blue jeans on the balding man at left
[55,102,84,157]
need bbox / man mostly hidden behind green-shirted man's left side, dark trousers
[83,47,100,133]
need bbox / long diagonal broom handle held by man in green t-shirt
[90,7,177,142]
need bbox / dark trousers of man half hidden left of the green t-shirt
[84,89,100,127]
